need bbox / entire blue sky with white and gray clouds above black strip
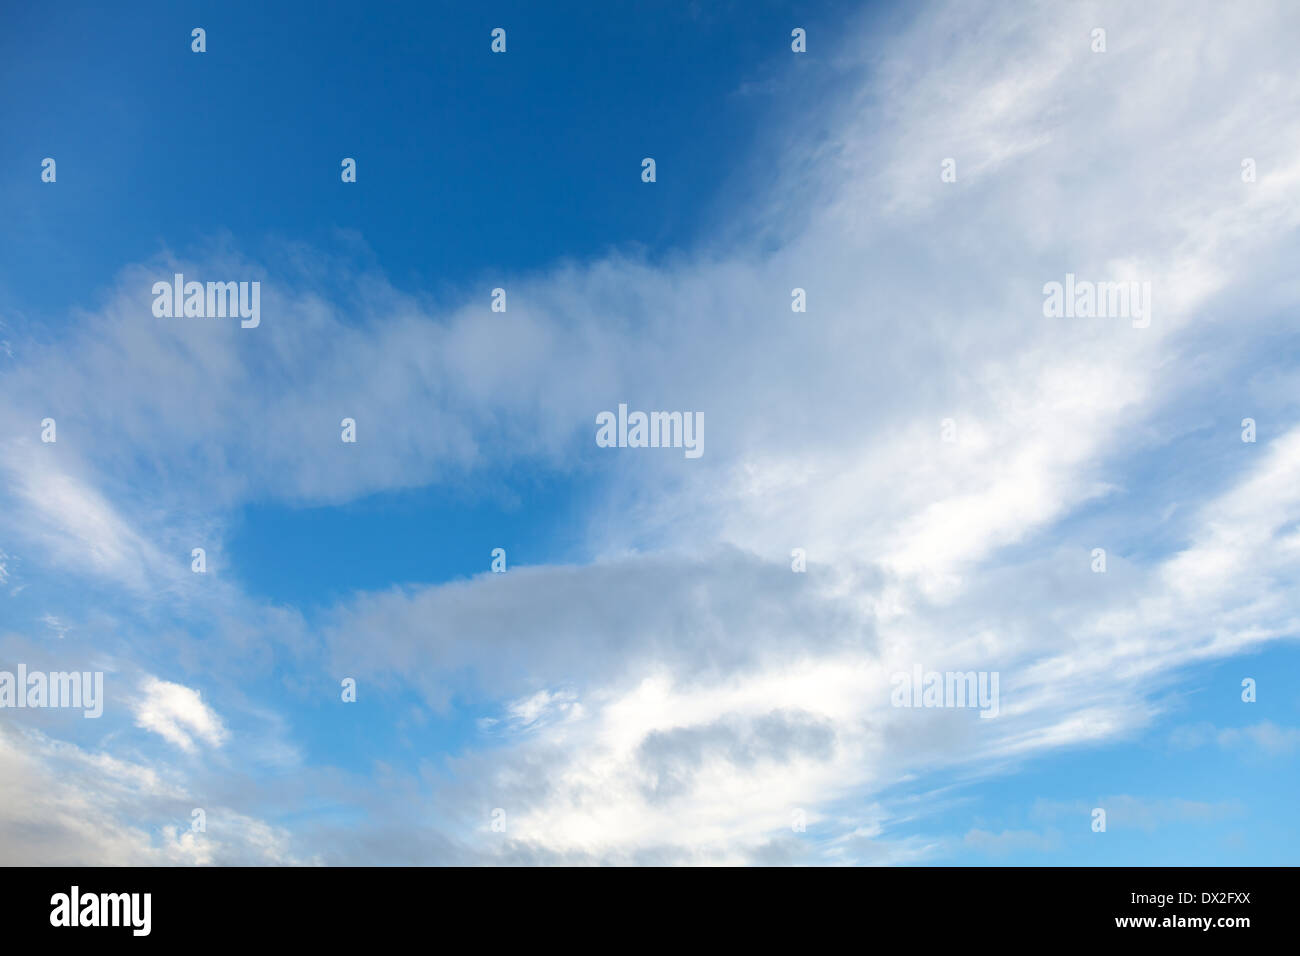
[0,3,1300,865]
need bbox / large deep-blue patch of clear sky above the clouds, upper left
[0,3,868,317]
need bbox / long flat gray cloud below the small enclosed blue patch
[326,549,875,706]
